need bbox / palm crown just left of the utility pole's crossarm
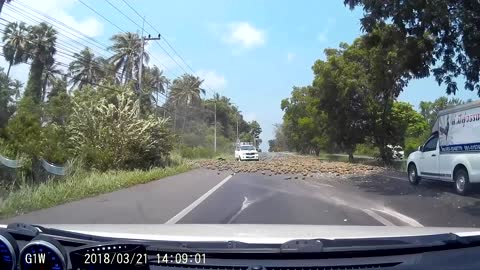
[109,32,150,83]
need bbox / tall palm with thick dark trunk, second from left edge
[25,23,57,103]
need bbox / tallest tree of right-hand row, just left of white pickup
[346,26,420,163]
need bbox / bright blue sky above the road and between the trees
[0,0,478,150]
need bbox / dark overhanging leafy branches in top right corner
[344,0,480,95]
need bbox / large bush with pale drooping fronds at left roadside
[67,90,173,171]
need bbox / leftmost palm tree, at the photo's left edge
[0,21,28,78]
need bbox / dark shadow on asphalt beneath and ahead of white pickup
[351,174,480,198]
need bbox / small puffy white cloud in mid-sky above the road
[222,22,266,49]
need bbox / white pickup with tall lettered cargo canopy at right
[407,101,480,195]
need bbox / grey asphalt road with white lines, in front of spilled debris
[0,153,480,227]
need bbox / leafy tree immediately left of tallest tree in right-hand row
[312,44,369,161]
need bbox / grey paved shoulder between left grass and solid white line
[0,169,229,224]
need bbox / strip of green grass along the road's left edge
[0,161,194,218]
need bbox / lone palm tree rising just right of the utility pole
[170,74,205,132]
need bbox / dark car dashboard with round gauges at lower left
[0,224,480,270]
